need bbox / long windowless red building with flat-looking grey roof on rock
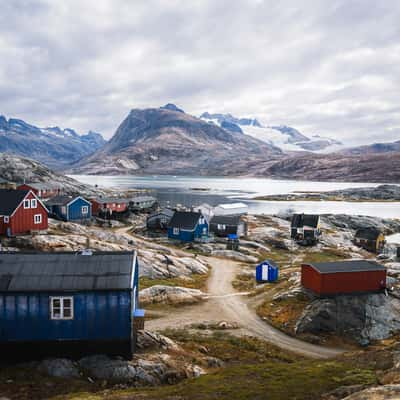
[301,260,386,296]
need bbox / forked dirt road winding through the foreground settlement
[146,258,342,358]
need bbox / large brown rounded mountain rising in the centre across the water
[69,104,282,175]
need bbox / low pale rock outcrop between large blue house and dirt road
[139,285,206,305]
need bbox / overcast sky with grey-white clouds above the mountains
[0,0,400,143]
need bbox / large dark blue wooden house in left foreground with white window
[0,250,144,359]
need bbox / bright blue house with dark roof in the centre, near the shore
[168,211,208,242]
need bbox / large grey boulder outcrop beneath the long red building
[296,294,400,345]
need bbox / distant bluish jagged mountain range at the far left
[0,116,105,169]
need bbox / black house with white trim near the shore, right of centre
[290,214,321,245]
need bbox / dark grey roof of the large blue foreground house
[0,252,135,292]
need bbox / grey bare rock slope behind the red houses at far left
[0,153,97,195]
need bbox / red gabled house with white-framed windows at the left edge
[0,189,48,236]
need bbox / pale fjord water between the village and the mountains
[72,175,400,218]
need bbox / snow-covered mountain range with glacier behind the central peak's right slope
[200,112,343,153]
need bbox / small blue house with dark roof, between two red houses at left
[46,196,92,221]
